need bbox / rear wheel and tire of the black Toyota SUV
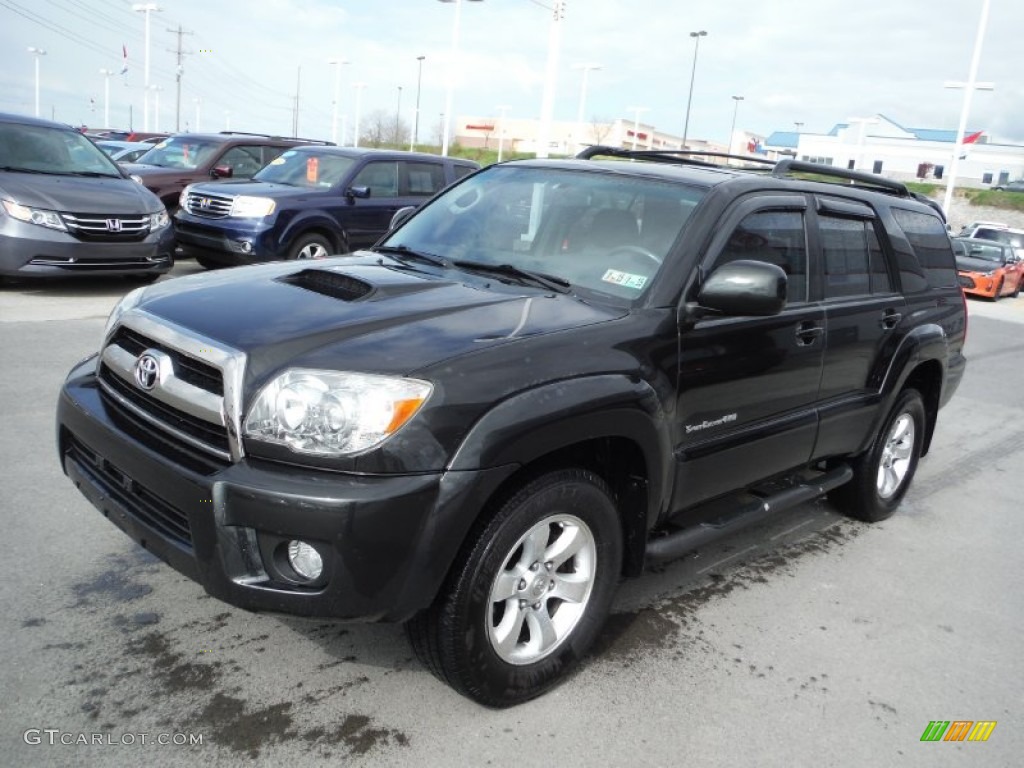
[828,389,927,522]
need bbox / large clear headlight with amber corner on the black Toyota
[244,369,433,456]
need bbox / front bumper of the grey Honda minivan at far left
[0,217,174,278]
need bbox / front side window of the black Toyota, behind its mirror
[715,211,807,303]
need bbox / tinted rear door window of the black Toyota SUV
[818,216,892,299]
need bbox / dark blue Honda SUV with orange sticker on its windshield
[174,146,479,266]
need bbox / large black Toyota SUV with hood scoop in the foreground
[57,147,967,707]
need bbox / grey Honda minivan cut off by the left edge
[0,114,174,281]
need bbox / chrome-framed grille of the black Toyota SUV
[98,319,244,461]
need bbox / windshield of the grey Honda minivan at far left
[0,123,121,177]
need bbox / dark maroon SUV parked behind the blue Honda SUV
[124,131,331,214]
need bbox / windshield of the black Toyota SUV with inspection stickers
[381,165,703,300]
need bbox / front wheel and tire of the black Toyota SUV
[406,469,623,708]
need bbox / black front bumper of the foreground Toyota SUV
[57,359,511,622]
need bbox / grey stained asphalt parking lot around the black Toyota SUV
[0,261,1024,767]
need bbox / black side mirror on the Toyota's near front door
[697,260,788,315]
